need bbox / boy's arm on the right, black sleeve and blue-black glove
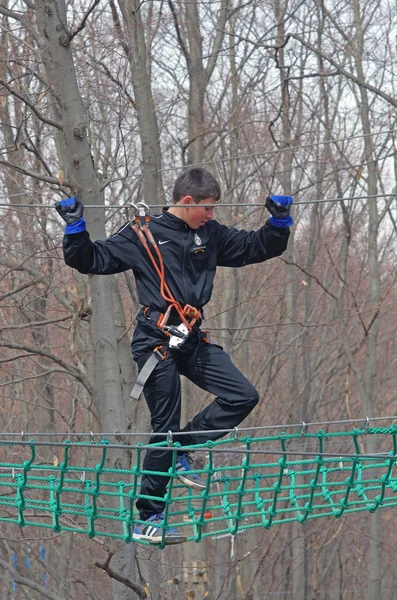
[216,196,293,267]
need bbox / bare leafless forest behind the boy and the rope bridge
[0,0,397,600]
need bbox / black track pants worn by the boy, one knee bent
[137,334,259,520]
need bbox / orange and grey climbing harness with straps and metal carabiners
[130,201,201,400]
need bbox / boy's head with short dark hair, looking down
[171,167,221,229]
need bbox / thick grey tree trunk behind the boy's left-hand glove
[36,0,133,600]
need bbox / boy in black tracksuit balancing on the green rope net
[56,168,293,544]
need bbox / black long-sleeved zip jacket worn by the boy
[63,208,289,356]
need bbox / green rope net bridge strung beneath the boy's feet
[0,417,397,546]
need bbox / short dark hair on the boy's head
[172,167,221,204]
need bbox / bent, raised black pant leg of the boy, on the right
[177,342,259,445]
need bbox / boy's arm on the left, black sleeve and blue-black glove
[55,196,136,275]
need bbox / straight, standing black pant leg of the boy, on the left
[136,353,181,520]
